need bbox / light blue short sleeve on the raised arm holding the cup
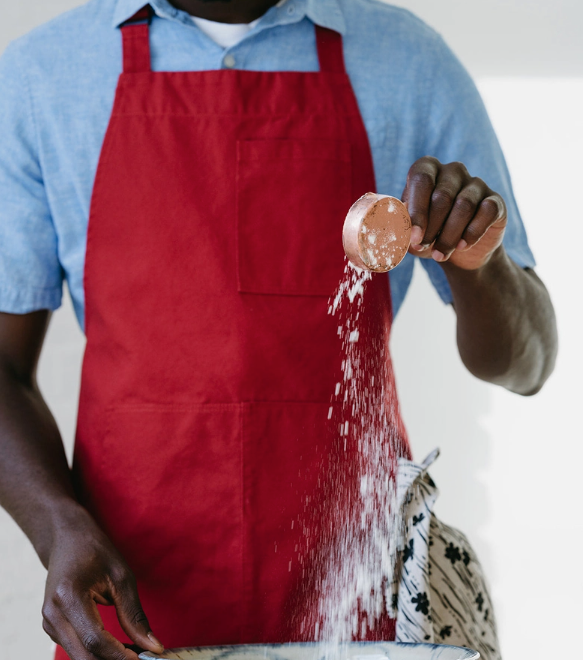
[420,35,535,303]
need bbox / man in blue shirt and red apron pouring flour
[0,0,556,660]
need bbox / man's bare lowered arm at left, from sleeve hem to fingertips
[0,310,164,660]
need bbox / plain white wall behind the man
[0,0,583,660]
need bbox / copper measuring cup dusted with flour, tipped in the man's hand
[342,193,411,273]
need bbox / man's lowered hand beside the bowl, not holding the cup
[43,514,164,660]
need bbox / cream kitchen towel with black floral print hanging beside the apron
[392,450,501,660]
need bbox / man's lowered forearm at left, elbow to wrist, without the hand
[0,369,87,567]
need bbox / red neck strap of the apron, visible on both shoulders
[121,5,346,73]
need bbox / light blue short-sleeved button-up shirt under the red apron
[0,0,534,327]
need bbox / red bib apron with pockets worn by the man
[62,9,408,657]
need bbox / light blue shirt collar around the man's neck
[113,0,346,34]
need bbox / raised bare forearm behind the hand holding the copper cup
[442,247,557,395]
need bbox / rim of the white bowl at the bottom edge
[140,642,480,660]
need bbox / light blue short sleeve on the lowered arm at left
[0,45,63,314]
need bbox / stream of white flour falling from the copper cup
[314,262,402,658]
